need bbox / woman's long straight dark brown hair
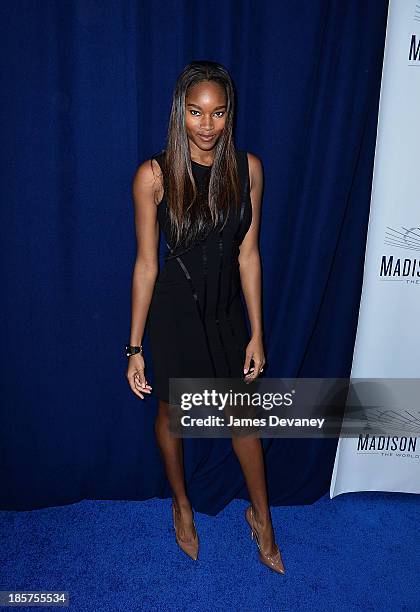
[157,61,240,246]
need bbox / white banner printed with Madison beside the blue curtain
[330,0,420,498]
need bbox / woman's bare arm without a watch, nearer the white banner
[238,153,265,378]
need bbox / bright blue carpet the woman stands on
[0,493,420,612]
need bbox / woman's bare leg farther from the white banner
[155,400,195,541]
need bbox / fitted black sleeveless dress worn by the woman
[148,150,252,402]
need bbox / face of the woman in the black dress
[185,81,226,152]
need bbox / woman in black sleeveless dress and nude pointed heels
[126,62,284,573]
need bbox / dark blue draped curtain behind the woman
[0,0,387,514]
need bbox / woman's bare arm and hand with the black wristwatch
[127,160,161,398]
